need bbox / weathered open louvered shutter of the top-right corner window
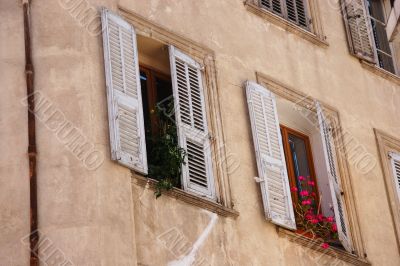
[341,0,376,63]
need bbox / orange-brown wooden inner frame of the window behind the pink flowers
[280,125,319,212]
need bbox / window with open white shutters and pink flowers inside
[246,82,354,252]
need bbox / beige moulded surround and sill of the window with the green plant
[118,5,239,217]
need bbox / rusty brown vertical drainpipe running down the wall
[22,0,39,266]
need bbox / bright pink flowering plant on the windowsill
[291,176,338,249]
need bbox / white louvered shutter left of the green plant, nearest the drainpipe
[101,9,147,174]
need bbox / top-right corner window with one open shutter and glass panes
[341,0,396,74]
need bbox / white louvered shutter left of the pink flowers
[246,81,296,229]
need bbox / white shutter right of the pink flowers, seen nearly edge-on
[315,102,352,252]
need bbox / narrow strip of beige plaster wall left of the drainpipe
[0,1,29,265]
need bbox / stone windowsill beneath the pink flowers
[277,227,371,266]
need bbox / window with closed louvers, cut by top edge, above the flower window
[259,0,310,30]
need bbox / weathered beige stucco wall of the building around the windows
[0,0,400,265]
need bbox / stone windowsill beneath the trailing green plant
[132,173,239,218]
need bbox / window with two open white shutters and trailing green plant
[102,9,217,201]
